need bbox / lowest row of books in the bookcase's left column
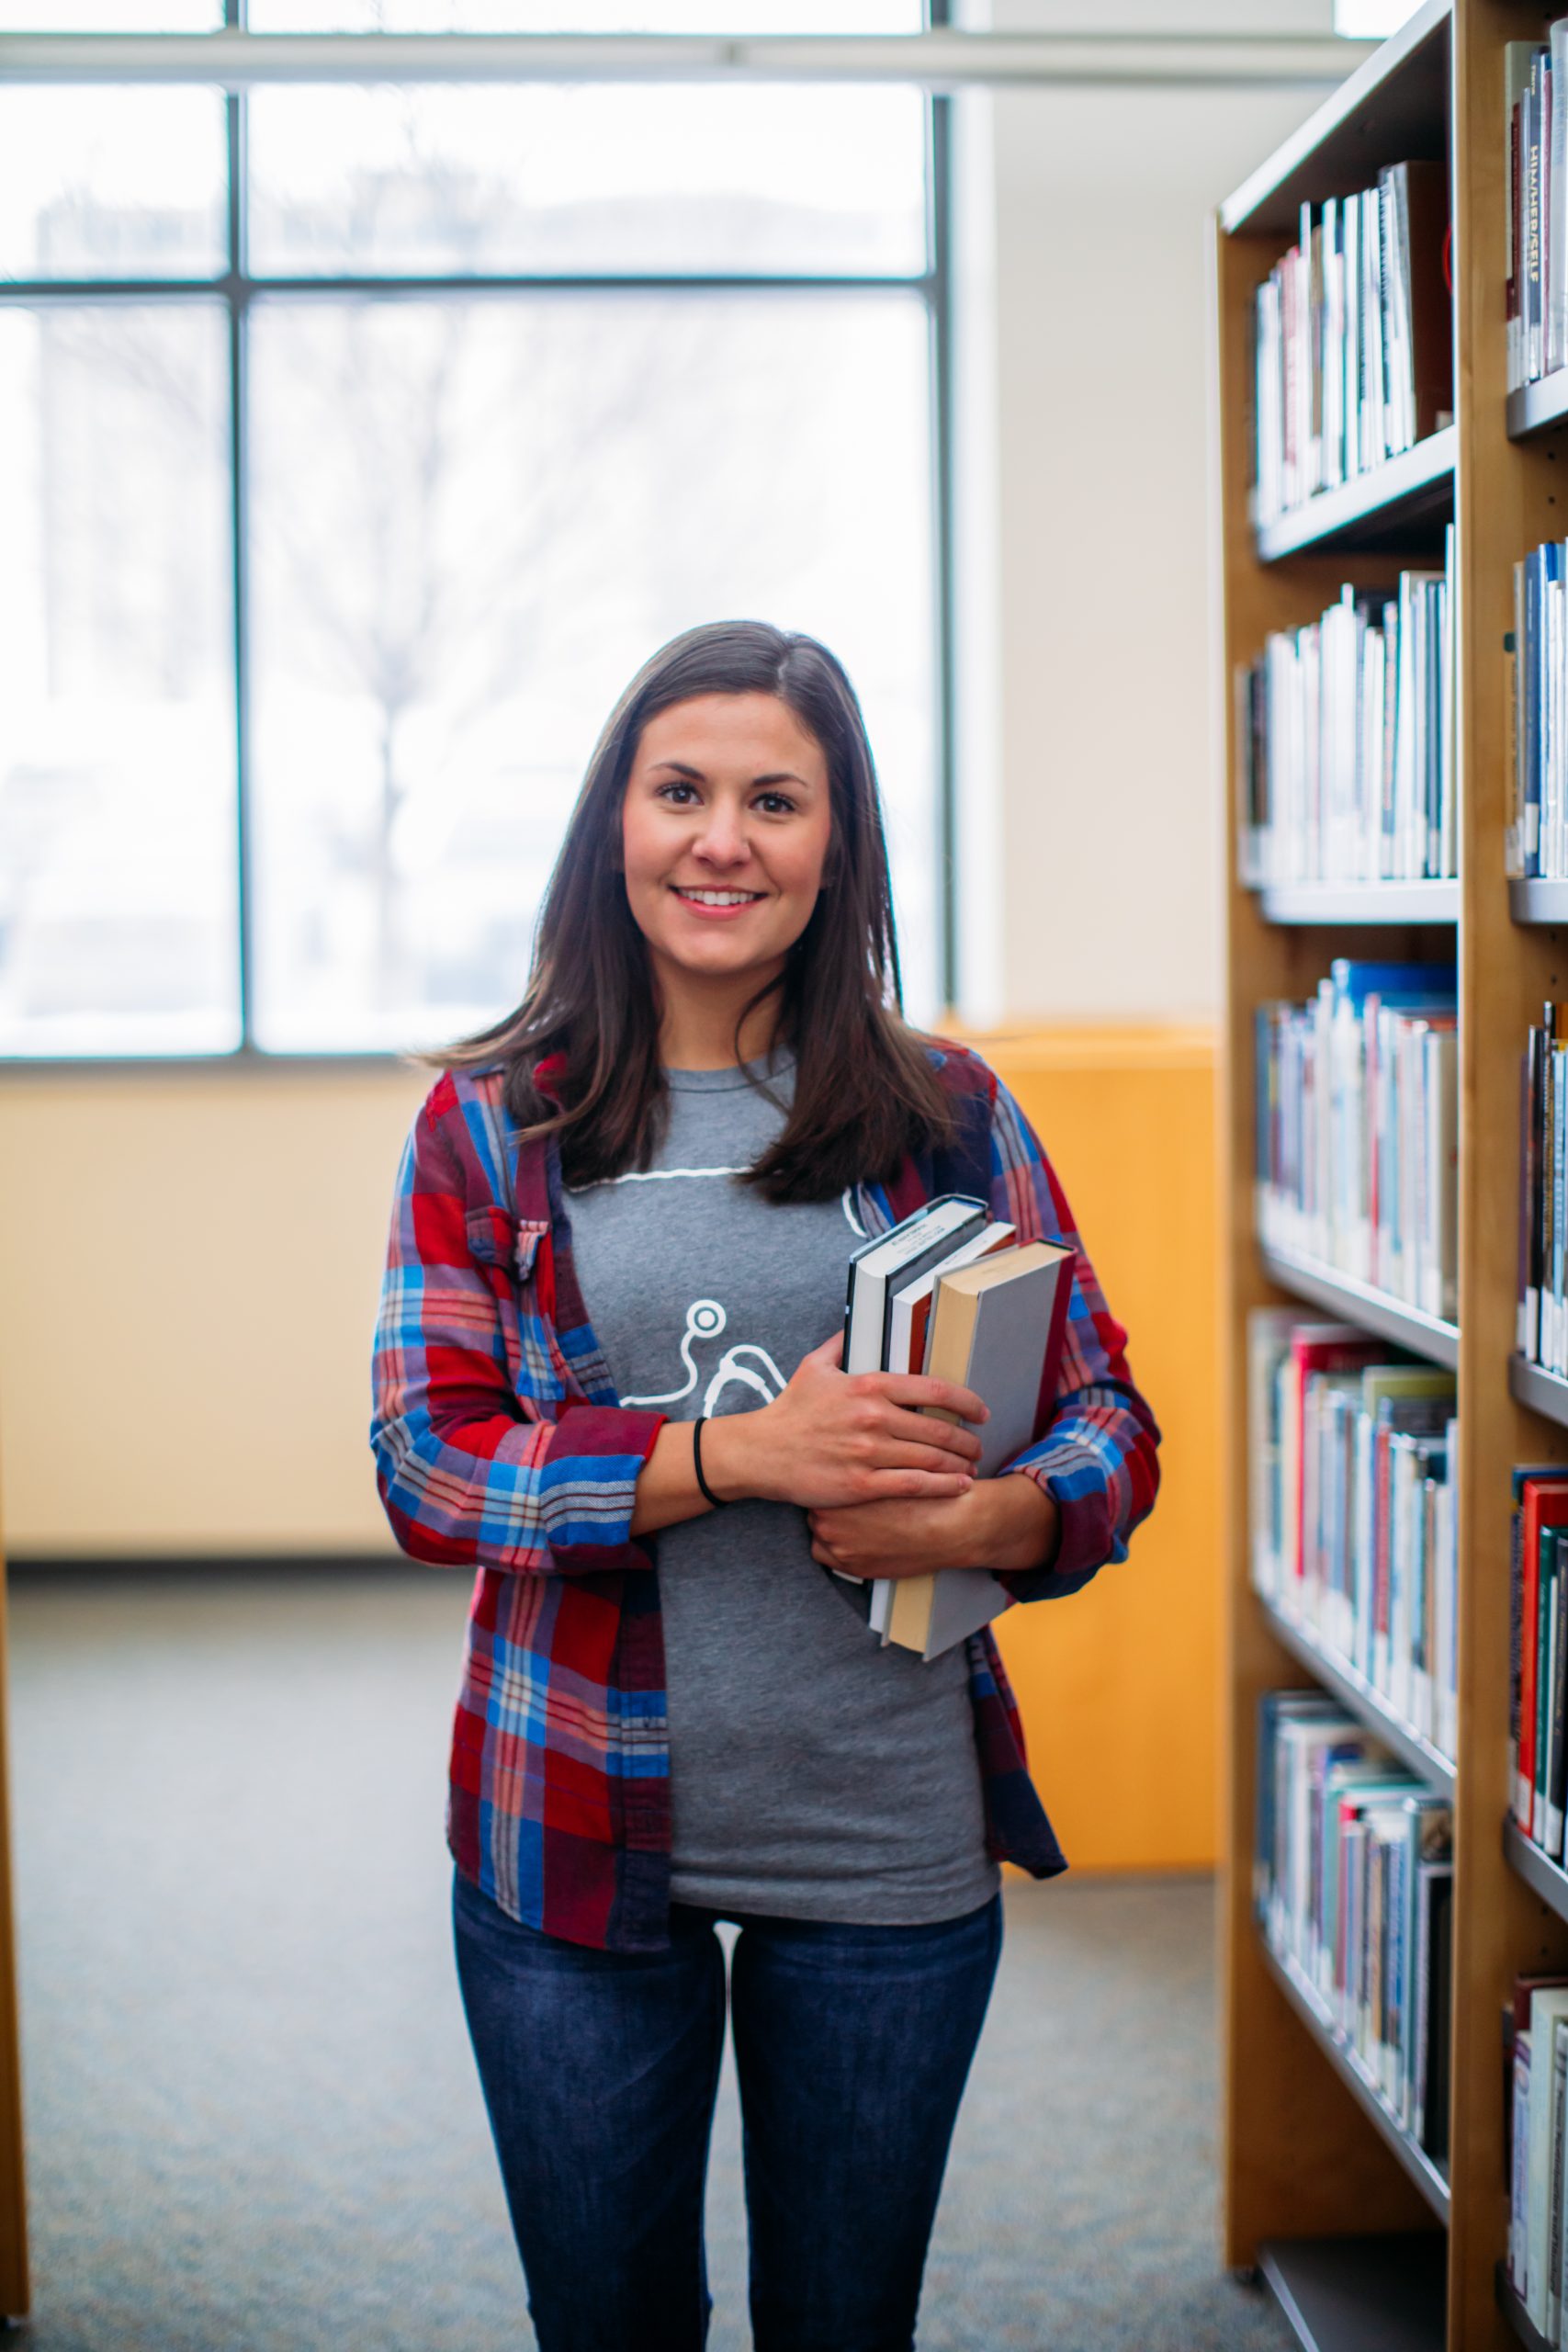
[1253,1691,1453,2162]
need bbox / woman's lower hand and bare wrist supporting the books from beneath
[807,1475,1058,1576]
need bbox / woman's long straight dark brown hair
[430,621,954,1200]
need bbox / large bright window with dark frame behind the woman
[0,0,941,1056]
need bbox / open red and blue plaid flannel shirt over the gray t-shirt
[371,1045,1159,1952]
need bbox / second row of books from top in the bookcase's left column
[1236,543,1458,885]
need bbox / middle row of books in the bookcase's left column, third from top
[1256,957,1458,1319]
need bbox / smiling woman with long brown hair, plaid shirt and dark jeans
[371,623,1159,2352]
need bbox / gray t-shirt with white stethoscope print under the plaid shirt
[567,1061,999,1924]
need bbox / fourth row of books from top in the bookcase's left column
[1246,1307,1460,1757]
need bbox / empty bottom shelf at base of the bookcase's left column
[1258,2230,1446,2352]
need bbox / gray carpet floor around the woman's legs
[12,1571,1293,2352]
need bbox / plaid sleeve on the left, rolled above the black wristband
[371,1089,663,1576]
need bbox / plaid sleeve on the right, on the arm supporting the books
[989,1080,1159,1601]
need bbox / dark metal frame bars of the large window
[0,0,959,1075]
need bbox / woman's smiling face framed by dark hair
[621,694,832,988]
